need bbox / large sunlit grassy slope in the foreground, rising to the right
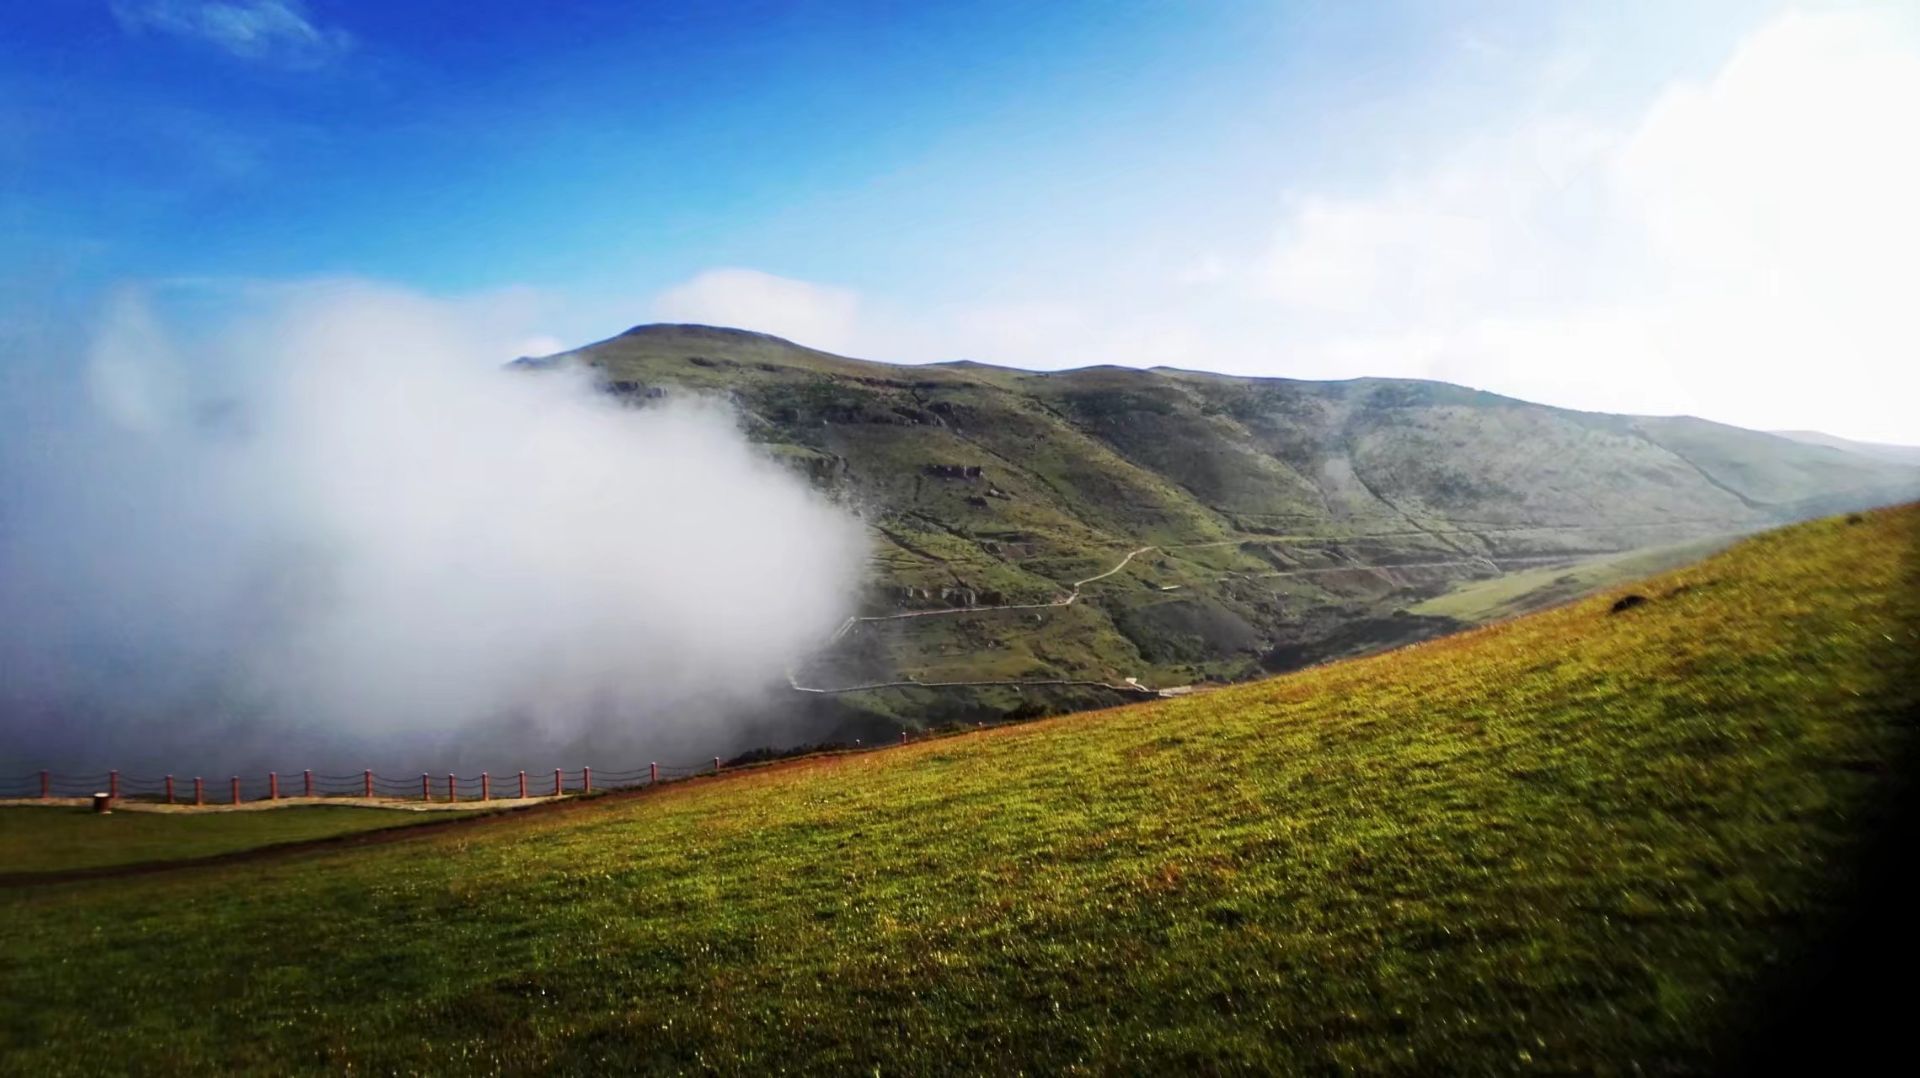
[0,507,1920,1072]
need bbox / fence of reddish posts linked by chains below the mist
[0,730,929,805]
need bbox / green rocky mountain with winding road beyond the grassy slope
[522,325,1920,726]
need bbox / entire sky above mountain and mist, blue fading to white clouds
[0,0,1920,440]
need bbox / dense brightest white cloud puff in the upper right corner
[1615,13,1920,432]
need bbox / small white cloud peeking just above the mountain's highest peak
[653,269,860,352]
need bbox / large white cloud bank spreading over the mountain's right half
[1261,12,1920,440]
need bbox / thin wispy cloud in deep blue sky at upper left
[111,0,353,67]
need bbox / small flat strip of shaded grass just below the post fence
[0,805,436,872]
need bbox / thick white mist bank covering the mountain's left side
[0,284,866,772]
